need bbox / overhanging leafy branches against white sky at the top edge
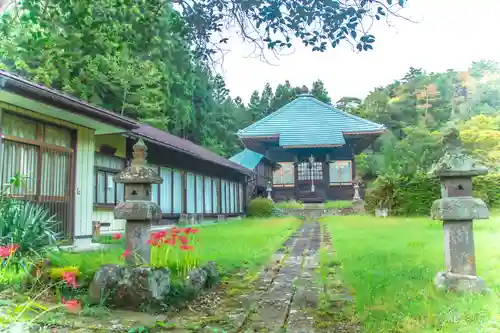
[173,0,407,62]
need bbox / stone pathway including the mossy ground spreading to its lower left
[25,217,359,333]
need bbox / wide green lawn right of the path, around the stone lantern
[325,215,500,333]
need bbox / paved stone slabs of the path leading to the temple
[177,218,357,333]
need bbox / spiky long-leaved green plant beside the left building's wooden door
[0,198,59,258]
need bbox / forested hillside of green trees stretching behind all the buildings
[0,0,500,182]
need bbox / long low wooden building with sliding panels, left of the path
[0,70,253,246]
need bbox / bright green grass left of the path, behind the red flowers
[50,217,300,279]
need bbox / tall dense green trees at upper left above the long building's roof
[0,0,197,135]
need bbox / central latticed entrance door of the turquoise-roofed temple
[297,161,326,203]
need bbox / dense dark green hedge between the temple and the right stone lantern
[365,172,440,215]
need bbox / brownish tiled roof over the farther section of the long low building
[132,124,253,175]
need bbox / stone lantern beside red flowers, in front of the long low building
[113,139,163,266]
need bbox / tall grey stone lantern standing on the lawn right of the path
[431,129,488,292]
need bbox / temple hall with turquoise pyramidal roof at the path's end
[234,94,385,202]
